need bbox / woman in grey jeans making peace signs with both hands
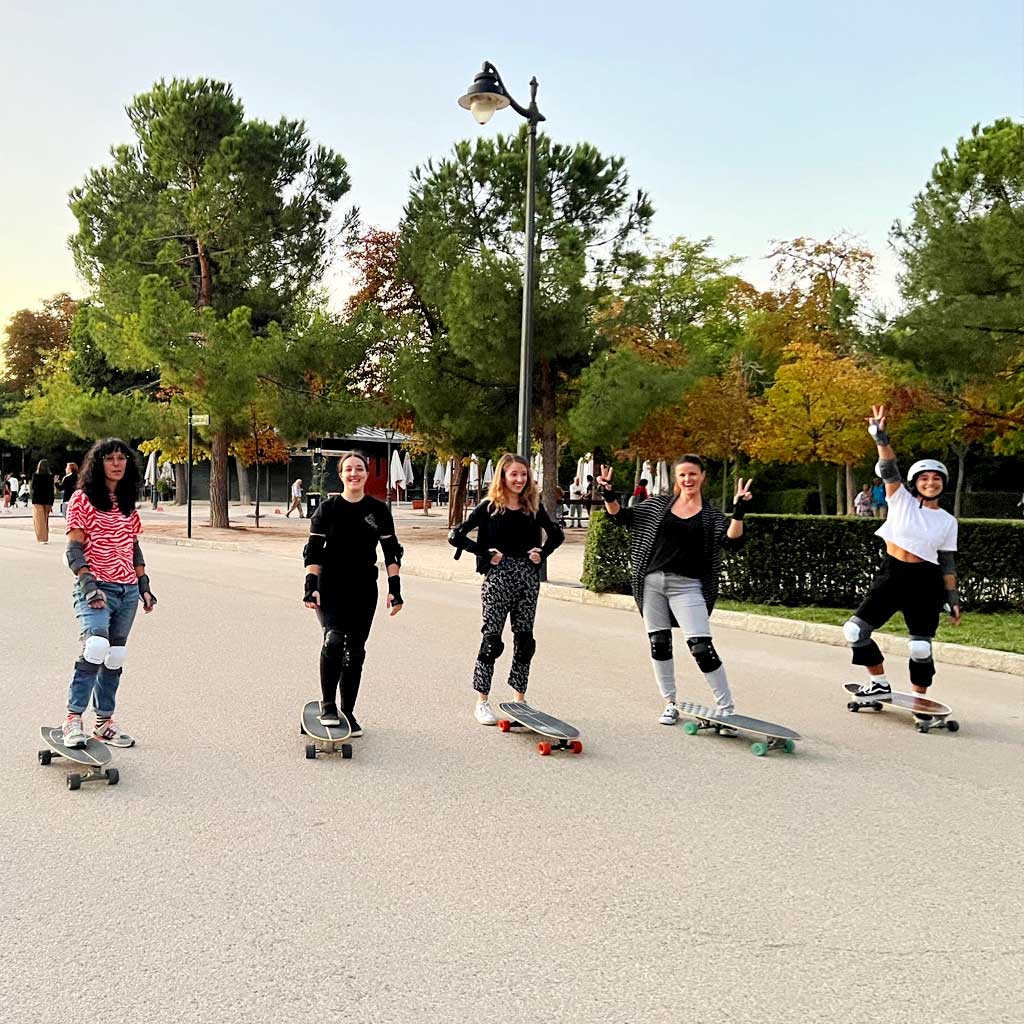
[597,455,752,725]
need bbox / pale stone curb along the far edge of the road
[145,535,1024,677]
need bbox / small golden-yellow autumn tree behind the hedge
[746,342,887,513]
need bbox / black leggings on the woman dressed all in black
[316,578,377,715]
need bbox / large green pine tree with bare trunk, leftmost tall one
[71,79,354,526]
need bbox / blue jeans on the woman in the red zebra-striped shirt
[68,581,138,718]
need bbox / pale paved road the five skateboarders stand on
[0,528,1024,1024]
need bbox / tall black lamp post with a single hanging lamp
[459,60,547,459]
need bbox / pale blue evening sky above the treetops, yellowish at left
[0,0,1024,325]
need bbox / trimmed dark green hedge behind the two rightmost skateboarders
[583,513,1024,611]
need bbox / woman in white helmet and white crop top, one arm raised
[843,406,961,700]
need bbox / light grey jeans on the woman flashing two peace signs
[643,572,734,712]
